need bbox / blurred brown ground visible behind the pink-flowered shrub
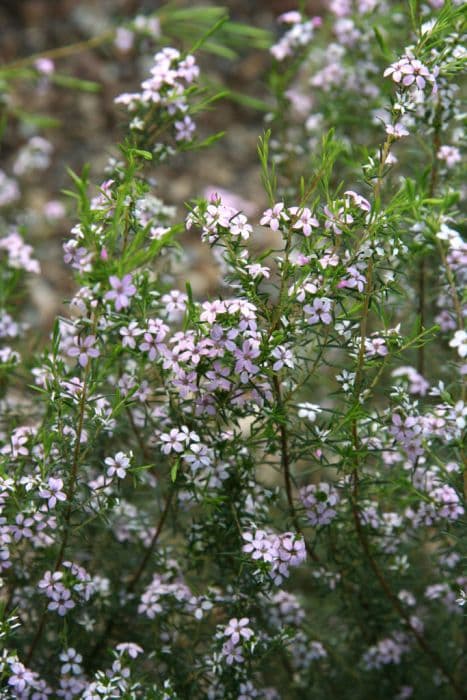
[0,0,330,331]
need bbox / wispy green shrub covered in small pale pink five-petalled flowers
[0,0,467,700]
